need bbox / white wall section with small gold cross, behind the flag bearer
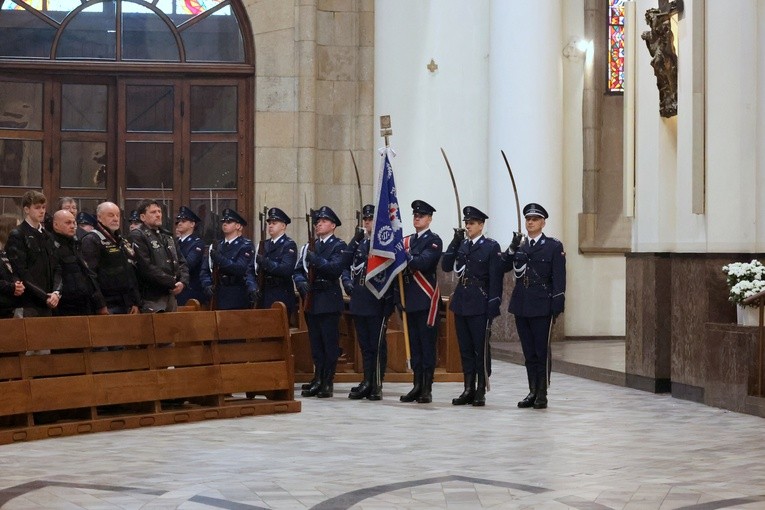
[375,0,494,237]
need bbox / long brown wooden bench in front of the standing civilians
[0,303,300,444]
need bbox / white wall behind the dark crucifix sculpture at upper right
[633,0,765,253]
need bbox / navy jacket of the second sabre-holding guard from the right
[441,236,504,318]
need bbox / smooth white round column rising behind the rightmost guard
[487,0,564,245]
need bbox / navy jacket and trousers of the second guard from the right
[441,236,504,378]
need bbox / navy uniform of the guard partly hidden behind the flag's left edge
[342,238,393,398]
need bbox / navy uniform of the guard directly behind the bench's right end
[251,235,297,315]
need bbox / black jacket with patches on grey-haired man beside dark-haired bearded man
[81,223,142,308]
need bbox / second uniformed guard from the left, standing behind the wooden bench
[200,209,256,310]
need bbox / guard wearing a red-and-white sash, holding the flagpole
[400,200,443,404]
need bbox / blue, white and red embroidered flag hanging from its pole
[366,147,406,299]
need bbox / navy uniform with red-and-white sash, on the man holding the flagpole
[403,230,443,378]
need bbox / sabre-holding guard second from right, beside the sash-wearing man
[441,206,504,406]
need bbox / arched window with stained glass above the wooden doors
[0,0,245,63]
